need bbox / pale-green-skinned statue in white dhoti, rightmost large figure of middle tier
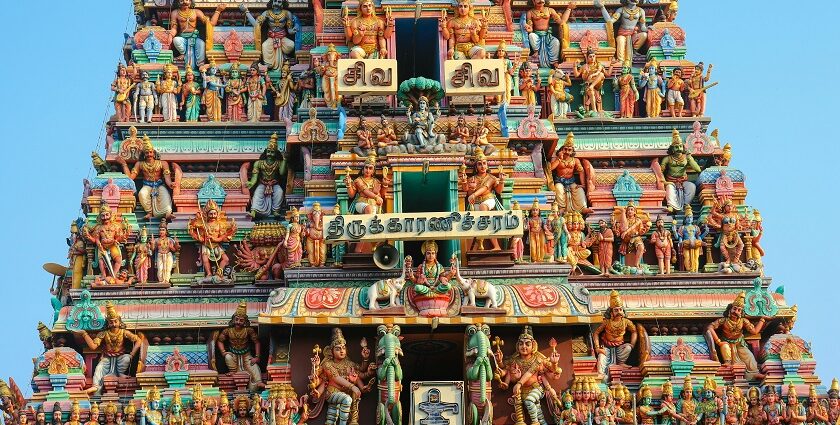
[660,129,701,212]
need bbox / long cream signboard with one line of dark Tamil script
[323,210,524,242]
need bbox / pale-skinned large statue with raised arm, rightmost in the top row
[592,0,647,63]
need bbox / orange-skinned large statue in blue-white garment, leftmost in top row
[169,0,227,68]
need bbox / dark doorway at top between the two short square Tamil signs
[396,18,440,83]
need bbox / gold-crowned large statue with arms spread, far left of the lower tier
[74,301,140,394]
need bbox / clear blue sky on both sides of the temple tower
[0,0,840,394]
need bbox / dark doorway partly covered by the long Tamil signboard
[402,171,452,260]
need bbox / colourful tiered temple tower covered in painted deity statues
[0,0,840,425]
